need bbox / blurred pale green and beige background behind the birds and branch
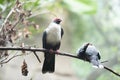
[0,0,120,80]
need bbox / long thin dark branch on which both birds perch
[0,47,120,77]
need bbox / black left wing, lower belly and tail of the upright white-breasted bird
[42,31,60,73]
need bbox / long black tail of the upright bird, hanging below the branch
[42,53,55,73]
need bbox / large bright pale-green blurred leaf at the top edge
[63,0,97,14]
